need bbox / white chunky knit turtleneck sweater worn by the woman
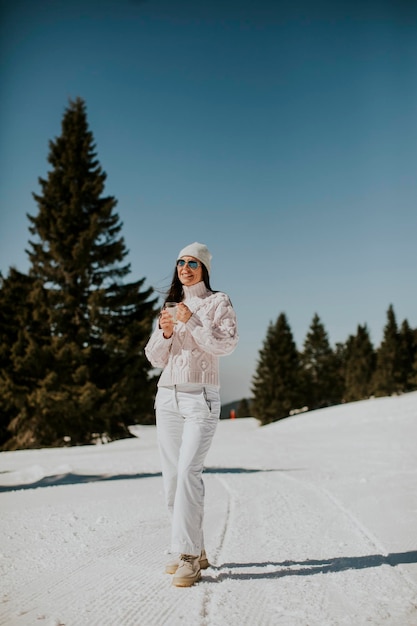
[145,282,238,387]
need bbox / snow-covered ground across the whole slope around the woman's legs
[0,393,417,626]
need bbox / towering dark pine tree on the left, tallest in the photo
[3,98,155,447]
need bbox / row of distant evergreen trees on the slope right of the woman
[249,305,417,424]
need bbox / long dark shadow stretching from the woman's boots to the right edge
[203,550,417,583]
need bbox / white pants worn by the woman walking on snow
[155,385,220,555]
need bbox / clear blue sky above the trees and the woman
[0,0,417,402]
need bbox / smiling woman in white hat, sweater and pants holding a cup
[145,242,238,587]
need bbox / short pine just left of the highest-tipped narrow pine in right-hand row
[343,324,375,402]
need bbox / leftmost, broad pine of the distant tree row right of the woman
[252,313,302,424]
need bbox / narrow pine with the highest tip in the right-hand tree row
[372,304,402,396]
